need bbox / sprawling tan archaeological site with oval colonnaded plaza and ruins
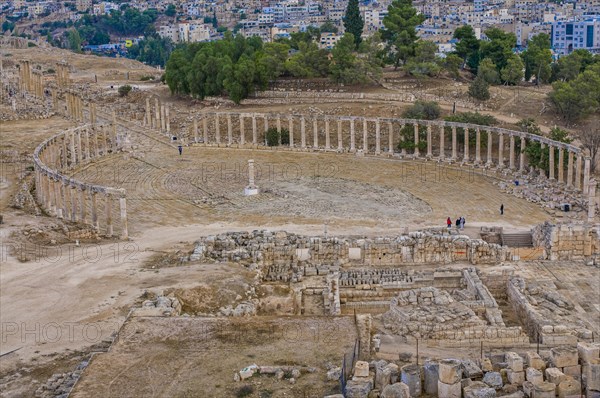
[0,44,600,398]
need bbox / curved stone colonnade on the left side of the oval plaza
[34,126,128,238]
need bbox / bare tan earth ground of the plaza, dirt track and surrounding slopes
[0,48,600,397]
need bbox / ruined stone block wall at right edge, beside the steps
[533,222,600,261]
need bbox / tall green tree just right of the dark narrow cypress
[382,0,425,68]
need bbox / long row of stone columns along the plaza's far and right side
[189,113,589,192]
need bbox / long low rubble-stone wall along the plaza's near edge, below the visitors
[189,231,510,274]
